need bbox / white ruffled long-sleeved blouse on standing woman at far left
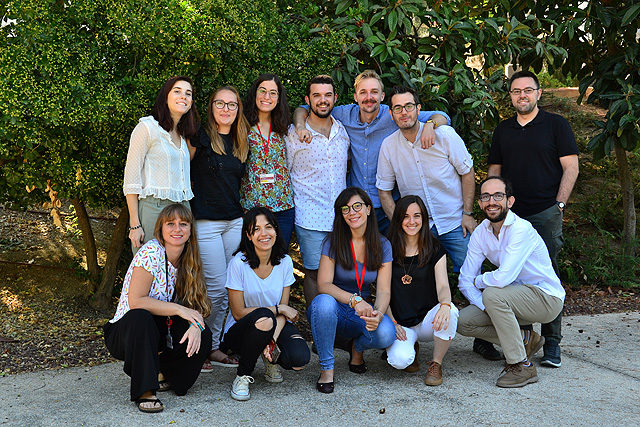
[122,116,193,202]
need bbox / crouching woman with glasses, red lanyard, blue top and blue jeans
[307,187,396,393]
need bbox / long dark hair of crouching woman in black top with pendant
[387,196,440,267]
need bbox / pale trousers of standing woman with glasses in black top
[196,218,242,350]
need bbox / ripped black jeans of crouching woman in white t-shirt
[220,307,311,376]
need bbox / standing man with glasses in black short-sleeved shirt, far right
[484,71,579,368]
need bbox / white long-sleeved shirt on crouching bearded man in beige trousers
[458,211,565,310]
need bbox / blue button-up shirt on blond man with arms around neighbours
[324,104,451,208]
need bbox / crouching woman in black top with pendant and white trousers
[387,196,458,386]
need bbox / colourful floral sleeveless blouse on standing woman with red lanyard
[240,126,293,212]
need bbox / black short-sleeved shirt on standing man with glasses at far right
[487,109,578,217]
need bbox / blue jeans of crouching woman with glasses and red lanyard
[307,294,396,371]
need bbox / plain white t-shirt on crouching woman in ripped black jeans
[223,252,296,335]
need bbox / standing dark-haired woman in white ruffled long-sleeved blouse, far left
[122,76,198,254]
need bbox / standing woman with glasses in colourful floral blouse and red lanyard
[241,74,295,248]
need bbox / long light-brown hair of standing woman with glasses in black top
[206,85,249,163]
